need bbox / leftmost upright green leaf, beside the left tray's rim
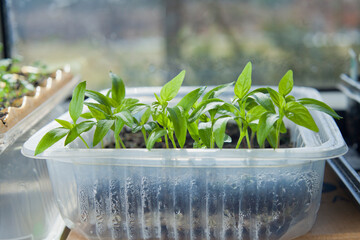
[69,81,86,123]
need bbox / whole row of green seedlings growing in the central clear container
[35,62,341,155]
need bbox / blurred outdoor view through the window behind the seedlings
[8,0,360,89]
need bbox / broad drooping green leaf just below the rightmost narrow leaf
[285,102,319,132]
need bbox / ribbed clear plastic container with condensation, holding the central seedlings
[22,88,347,240]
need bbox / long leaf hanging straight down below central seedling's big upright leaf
[168,106,187,148]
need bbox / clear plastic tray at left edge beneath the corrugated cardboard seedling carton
[0,74,79,240]
